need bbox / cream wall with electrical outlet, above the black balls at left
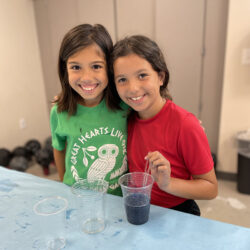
[0,0,50,150]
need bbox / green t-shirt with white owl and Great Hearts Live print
[50,100,128,195]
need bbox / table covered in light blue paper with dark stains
[0,167,250,250]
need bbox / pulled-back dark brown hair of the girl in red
[107,35,172,104]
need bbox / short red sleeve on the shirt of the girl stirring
[178,113,214,175]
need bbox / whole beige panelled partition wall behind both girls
[35,0,228,156]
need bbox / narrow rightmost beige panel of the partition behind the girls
[200,0,228,154]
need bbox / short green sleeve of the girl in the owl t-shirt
[50,105,66,151]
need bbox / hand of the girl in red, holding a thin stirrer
[145,151,171,190]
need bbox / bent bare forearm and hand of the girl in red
[146,151,218,200]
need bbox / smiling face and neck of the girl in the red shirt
[114,54,166,119]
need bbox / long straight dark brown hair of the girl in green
[54,24,118,115]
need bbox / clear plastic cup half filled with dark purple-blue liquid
[119,172,154,225]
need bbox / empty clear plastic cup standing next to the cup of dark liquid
[71,179,109,234]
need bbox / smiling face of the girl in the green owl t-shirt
[67,44,108,107]
